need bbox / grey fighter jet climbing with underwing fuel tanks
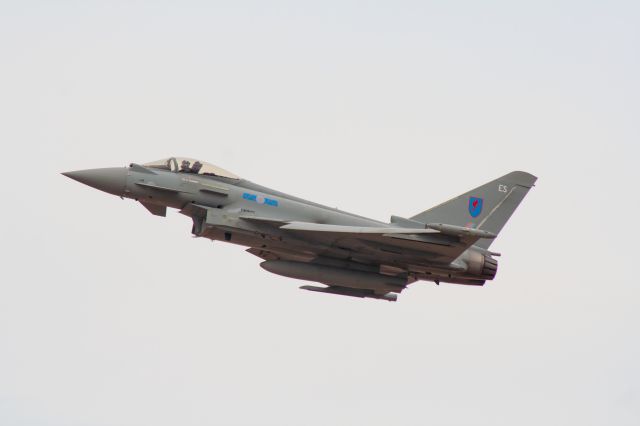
[63,157,537,301]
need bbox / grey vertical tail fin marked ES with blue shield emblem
[411,172,537,249]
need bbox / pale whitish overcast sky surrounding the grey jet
[0,1,640,426]
